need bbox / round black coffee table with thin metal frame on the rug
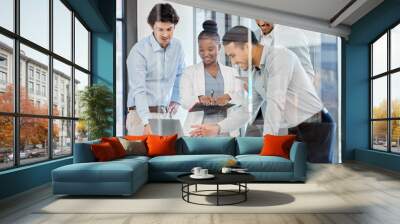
[177,173,255,206]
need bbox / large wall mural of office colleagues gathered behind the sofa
[126,1,339,162]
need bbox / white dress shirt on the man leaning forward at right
[254,46,323,135]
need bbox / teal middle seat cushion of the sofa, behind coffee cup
[149,154,235,172]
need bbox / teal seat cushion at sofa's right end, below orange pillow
[236,155,293,172]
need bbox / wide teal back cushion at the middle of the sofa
[176,137,235,156]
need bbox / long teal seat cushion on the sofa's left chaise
[52,159,147,182]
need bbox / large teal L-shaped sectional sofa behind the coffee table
[52,137,306,195]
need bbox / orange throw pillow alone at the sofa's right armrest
[260,134,296,159]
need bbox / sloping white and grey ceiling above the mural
[170,0,383,37]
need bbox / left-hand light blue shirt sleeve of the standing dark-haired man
[126,47,150,124]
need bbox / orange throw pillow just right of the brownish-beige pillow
[146,135,178,156]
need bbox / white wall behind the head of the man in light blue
[137,0,195,66]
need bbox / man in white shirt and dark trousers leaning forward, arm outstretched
[195,26,335,162]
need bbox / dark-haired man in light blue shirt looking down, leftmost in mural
[126,3,185,135]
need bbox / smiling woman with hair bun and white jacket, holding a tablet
[180,20,243,136]
